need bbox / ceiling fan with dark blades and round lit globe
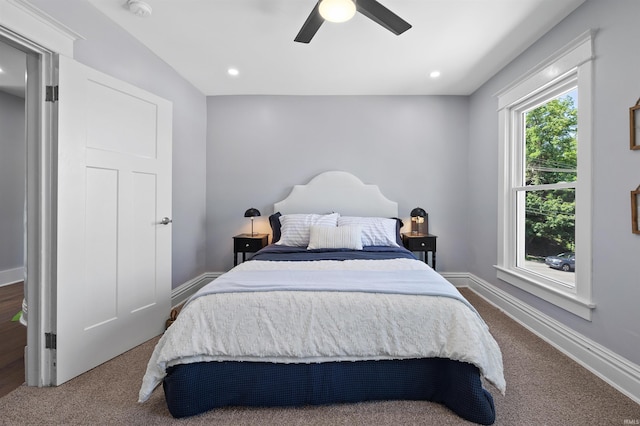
[295,0,411,43]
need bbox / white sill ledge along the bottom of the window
[494,265,596,321]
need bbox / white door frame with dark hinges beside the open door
[0,28,55,386]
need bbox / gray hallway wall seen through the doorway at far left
[0,91,26,276]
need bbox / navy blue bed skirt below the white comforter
[163,358,495,424]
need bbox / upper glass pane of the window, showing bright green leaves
[524,89,578,185]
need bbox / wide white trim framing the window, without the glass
[495,31,595,320]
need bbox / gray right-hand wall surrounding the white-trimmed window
[467,0,640,364]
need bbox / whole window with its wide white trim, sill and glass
[497,33,594,319]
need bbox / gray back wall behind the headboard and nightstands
[207,96,469,271]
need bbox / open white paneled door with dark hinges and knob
[52,56,172,385]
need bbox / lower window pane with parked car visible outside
[518,189,576,286]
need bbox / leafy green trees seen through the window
[520,89,578,285]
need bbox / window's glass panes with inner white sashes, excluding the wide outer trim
[512,85,578,288]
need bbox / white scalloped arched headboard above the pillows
[273,171,398,217]
